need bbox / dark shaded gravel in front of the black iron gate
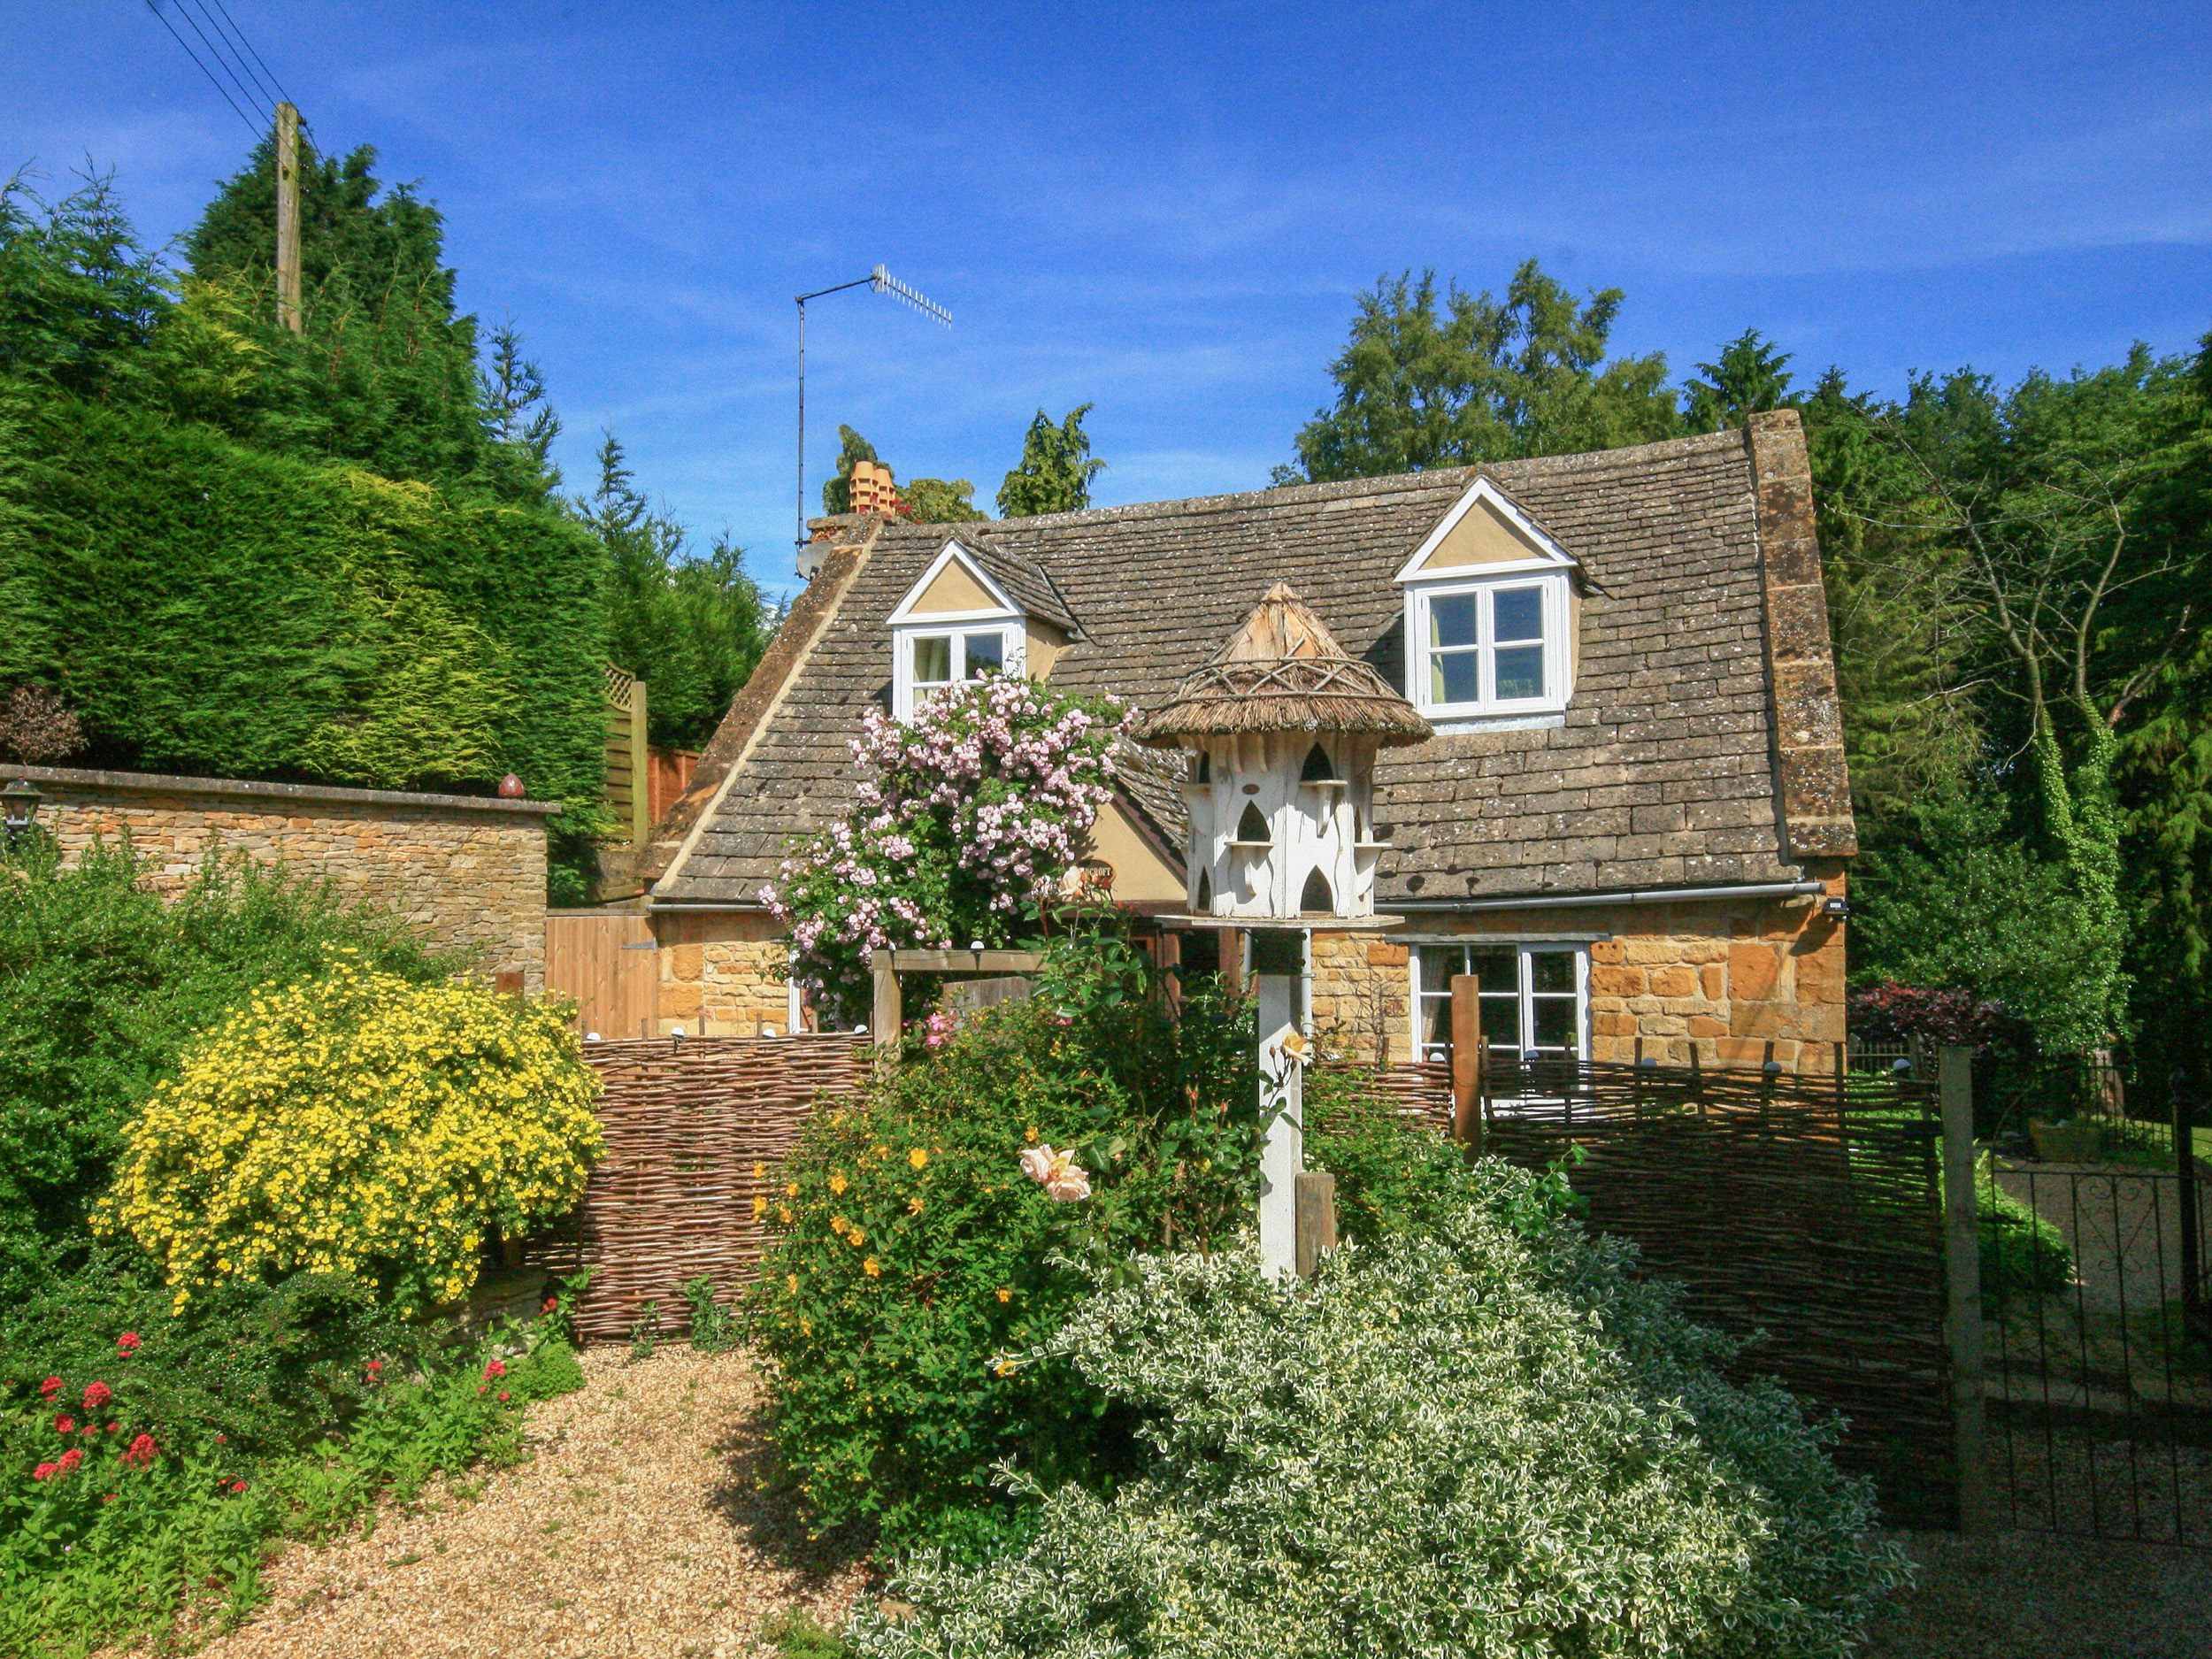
[1861,1533,2212,1659]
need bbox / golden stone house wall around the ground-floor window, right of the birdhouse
[1312,863,1845,1073]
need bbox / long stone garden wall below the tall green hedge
[0,765,560,995]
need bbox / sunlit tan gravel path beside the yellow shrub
[177,1348,865,1659]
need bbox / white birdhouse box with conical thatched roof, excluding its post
[1137,582,1432,927]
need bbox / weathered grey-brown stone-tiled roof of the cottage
[655,419,1852,910]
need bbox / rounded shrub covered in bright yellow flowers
[96,951,604,1308]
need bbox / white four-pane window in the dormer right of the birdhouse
[1407,573,1573,719]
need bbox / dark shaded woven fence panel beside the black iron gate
[1327,1062,1955,1526]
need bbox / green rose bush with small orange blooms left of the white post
[748,945,1259,1551]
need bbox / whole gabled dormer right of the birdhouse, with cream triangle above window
[1394,476,1591,733]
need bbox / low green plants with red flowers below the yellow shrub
[0,1301,584,1659]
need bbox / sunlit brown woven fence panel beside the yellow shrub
[526,1035,872,1340]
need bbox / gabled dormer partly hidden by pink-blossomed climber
[889,538,1079,721]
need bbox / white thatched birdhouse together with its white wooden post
[1135,582,1432,1274]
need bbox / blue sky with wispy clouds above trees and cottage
[0,0,2212,588]
